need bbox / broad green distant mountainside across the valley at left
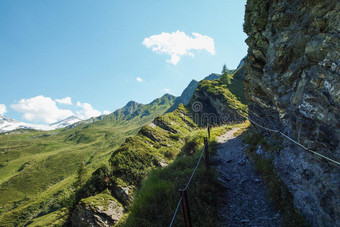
[0,95,175,226]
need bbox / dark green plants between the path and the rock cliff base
[243,128,307,226]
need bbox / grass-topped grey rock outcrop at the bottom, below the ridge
[72,192,124,227]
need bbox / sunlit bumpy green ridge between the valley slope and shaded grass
[72,104,197,225]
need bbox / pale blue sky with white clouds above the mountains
[0,0,247,124]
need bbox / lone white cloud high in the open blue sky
[143,31,215,65]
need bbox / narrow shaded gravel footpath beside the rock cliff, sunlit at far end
[213,128,281,226]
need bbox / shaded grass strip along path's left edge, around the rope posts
[121,126,236,226]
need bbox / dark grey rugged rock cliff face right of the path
[244,0,340,226]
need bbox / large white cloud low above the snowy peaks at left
[11,95,73,124]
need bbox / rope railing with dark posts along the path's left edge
[169,125,210,227]
